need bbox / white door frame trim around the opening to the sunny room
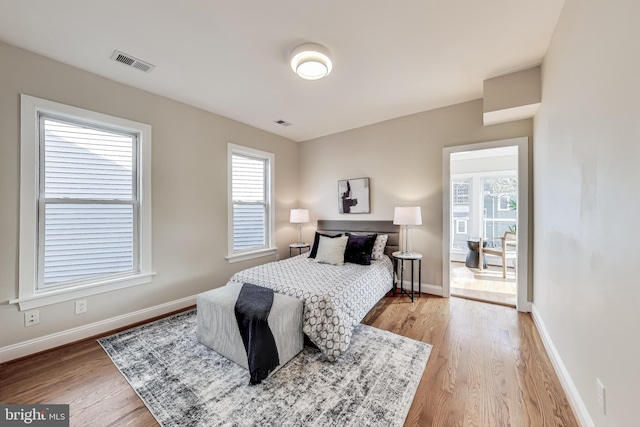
[442,136,531,312]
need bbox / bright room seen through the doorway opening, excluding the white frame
[449,146,518,307]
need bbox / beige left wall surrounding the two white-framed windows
[0,43,298,349]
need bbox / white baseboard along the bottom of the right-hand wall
[531,304,595,427]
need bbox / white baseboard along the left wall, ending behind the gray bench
[0,295,196,363]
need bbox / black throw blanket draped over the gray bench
[235,283,280,385]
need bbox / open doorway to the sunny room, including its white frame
[443,138,530,311]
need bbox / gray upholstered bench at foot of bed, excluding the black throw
[197,283,304,369]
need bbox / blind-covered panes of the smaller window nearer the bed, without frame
[231,153,269,252]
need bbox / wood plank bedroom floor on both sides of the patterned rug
[0,294,578,427]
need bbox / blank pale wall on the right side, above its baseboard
[534,0,640,426]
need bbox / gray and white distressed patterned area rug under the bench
[98,310,431,427]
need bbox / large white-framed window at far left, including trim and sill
[12,95,151,309]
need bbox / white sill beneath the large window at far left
[9,273,156,311]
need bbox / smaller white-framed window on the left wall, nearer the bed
[227,144,275,262]
